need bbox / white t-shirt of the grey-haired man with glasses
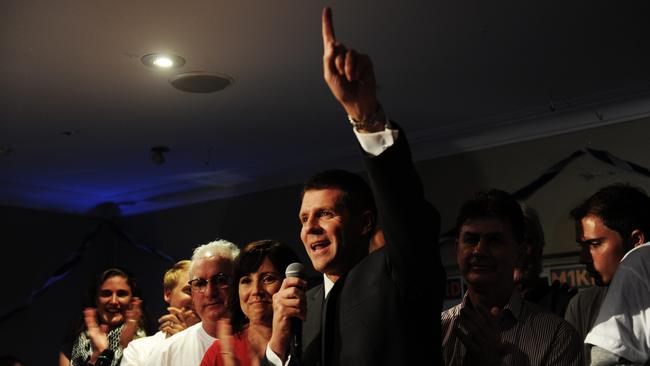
[145,322,217,366]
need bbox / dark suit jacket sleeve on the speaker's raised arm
[364,124,446,309]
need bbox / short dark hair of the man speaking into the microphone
[300,169,377,217]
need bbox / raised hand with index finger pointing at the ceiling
[322,7,383,123]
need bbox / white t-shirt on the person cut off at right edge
[585,243,650,364]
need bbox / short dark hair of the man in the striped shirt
[456,189,524,243]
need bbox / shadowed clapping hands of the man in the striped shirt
[455,304,505,366]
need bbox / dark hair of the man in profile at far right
[570,183,650,241]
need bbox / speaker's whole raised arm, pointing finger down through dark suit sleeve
[322,8,445,302]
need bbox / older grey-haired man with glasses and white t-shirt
[147,240,239,366]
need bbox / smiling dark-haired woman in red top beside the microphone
[201,240,299,366]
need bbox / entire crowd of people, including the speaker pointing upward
[7,8,650,366]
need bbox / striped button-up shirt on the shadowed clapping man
[442,291,582,366]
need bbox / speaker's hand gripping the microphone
[269,277,307,360]
